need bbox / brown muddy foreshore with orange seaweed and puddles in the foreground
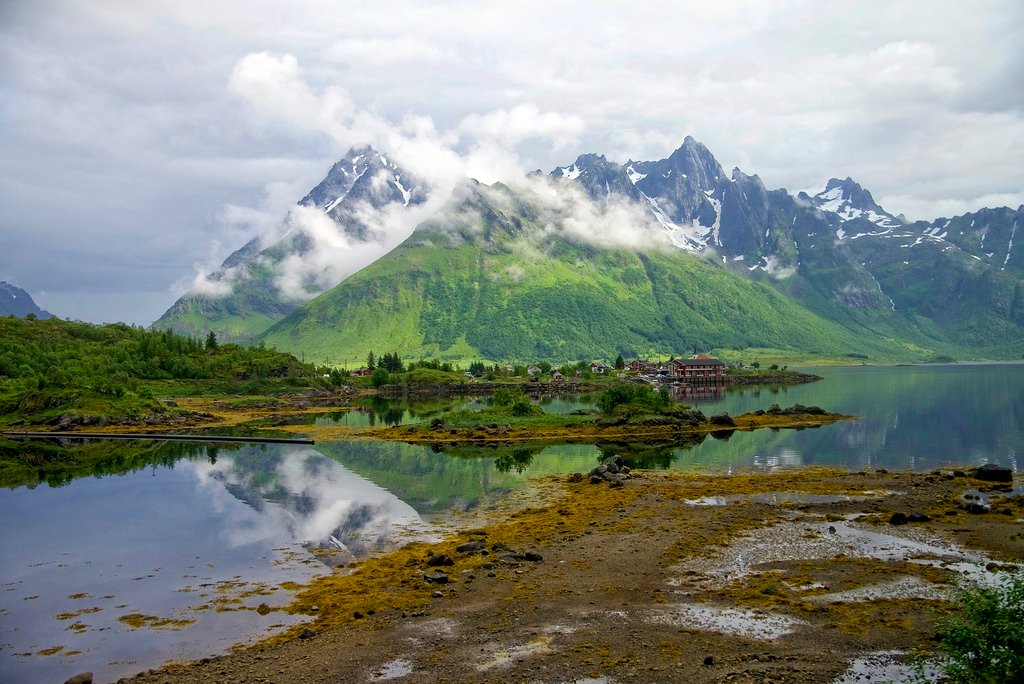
[123,469,1024,684]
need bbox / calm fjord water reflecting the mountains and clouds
[0,364,1024,682]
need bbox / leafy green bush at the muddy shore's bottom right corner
[937,573,1024,683]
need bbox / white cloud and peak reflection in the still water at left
[182,446,423,556]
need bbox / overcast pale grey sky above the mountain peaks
[0,0,1024,325]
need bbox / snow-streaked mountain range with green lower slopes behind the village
[155,137,1024,365]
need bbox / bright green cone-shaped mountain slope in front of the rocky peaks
[262,185,934,362]
